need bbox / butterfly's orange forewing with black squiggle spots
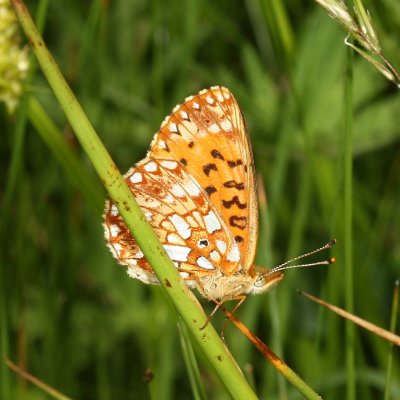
[148,87,258,273]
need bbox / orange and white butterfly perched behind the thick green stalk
[103,86,283,304]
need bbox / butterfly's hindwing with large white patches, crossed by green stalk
[104,158,240,287]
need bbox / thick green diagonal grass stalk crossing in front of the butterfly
[12,0,256,399]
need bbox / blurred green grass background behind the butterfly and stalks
[0,0,400,400]
